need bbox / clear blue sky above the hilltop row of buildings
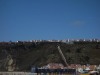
[0,0,100,41]
